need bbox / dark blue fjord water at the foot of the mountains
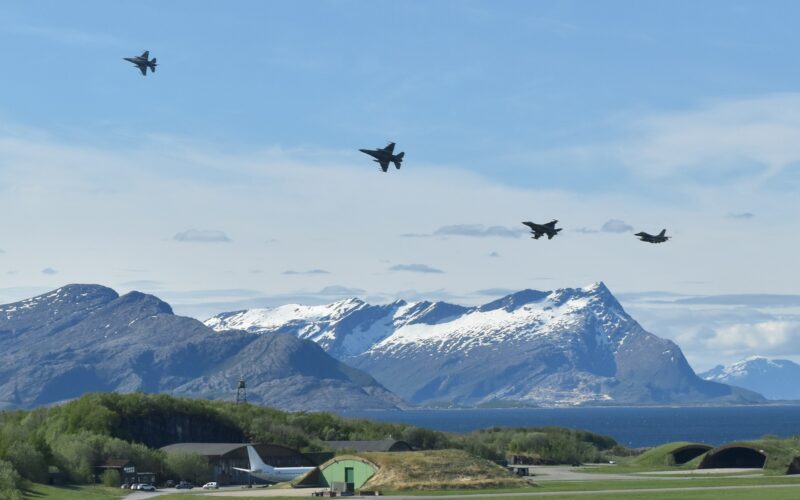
[341,405,800,448]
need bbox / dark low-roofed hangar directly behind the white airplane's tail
[161,443,317,485]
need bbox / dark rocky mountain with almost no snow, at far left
[0,285,403,410]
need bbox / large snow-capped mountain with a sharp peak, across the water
[206,283,763,404]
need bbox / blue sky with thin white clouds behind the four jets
[0,1,800,368]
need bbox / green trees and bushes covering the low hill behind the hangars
[0,393,621,500]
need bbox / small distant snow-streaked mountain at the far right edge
[700,356,800,400]
